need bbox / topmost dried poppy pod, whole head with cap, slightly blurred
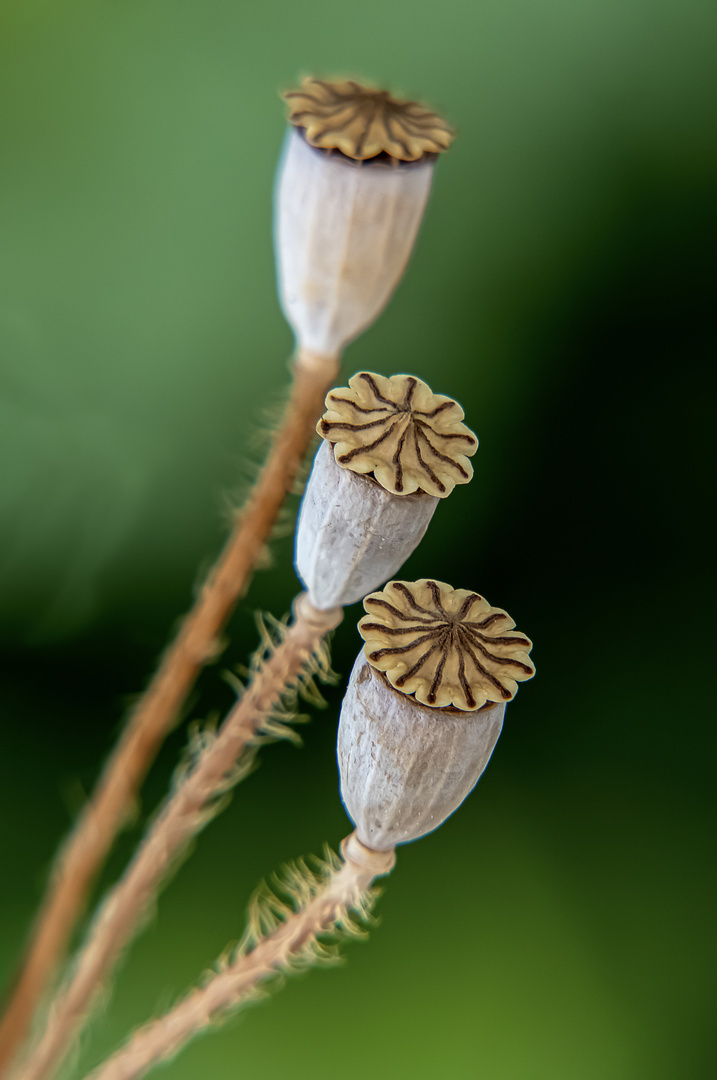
[275,79,452,357]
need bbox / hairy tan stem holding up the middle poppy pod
[12,593,342,1080]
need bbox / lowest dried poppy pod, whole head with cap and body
[338,579,535,851]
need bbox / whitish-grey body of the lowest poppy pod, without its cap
[337,652,505,851]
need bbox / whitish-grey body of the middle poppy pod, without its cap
[296,440,439,610]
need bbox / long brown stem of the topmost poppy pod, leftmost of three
[0,352,338,1076]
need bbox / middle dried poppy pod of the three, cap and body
[296,372,478,609]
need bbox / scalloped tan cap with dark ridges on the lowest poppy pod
[359,578,536,712]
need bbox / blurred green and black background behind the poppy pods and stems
[0,0,717,1080]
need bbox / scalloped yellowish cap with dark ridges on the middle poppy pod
[316,372,478,498]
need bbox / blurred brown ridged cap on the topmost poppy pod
[283,78,454,163]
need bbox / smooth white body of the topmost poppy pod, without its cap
[275,129,433,356]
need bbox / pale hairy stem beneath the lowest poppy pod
[86,833,394,1080]
